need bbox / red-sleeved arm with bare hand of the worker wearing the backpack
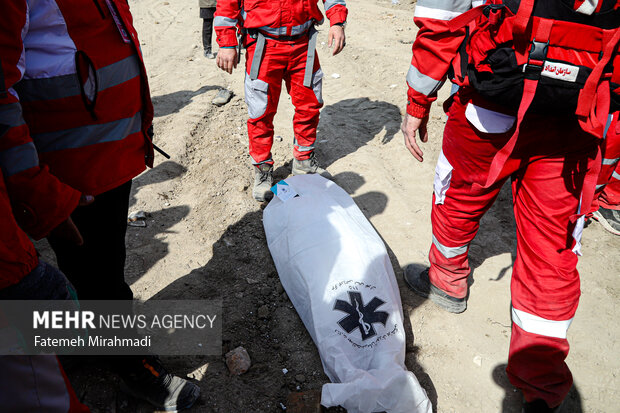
[401,0,472,162]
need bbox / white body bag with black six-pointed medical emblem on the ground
[263,175,432,413]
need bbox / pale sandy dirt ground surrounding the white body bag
[44,0,620,413]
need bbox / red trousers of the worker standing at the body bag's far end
[245,36,323,164]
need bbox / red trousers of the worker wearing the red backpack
[429,92,598,407]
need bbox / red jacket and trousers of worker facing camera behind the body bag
[213,0,347,165]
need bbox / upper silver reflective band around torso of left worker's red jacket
[15,55,140,102]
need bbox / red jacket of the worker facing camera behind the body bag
[213,0,347,47]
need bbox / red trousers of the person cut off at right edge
[592,112,620,211]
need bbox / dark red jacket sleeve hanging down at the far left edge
[0,0,81,239]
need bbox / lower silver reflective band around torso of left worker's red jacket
[33,112,142,152]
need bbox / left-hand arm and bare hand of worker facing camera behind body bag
[213,0,241,73]
